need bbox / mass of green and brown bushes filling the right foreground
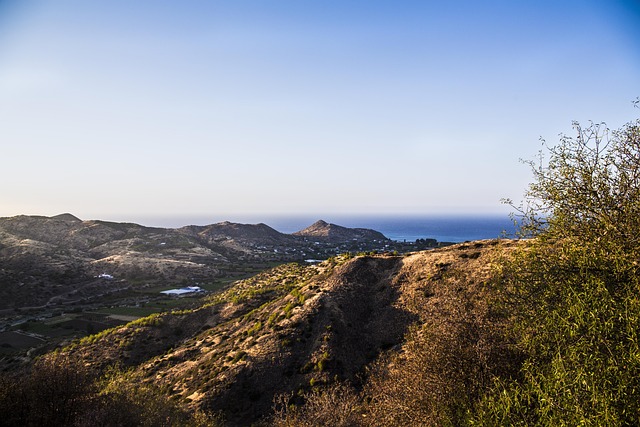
[276,104,640,426]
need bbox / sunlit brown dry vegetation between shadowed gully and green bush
[272,241,522,426]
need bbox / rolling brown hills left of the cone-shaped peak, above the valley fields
[0,214,396,310]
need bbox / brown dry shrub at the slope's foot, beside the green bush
[365,272,520,426]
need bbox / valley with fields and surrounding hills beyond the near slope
[0,214,445,367]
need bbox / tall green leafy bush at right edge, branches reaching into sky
[474,102,640,426]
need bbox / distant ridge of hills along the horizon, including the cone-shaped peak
[0,213,386,278]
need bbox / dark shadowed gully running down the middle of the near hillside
[206,257,417,426]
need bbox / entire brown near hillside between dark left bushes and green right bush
[23,240,517,426]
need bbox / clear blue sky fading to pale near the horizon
[0,0,640,224]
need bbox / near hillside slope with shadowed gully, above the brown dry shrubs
[53,241,515,426]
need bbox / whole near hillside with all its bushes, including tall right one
[0,102,640,427]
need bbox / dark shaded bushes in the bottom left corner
[0,354,213,427]
